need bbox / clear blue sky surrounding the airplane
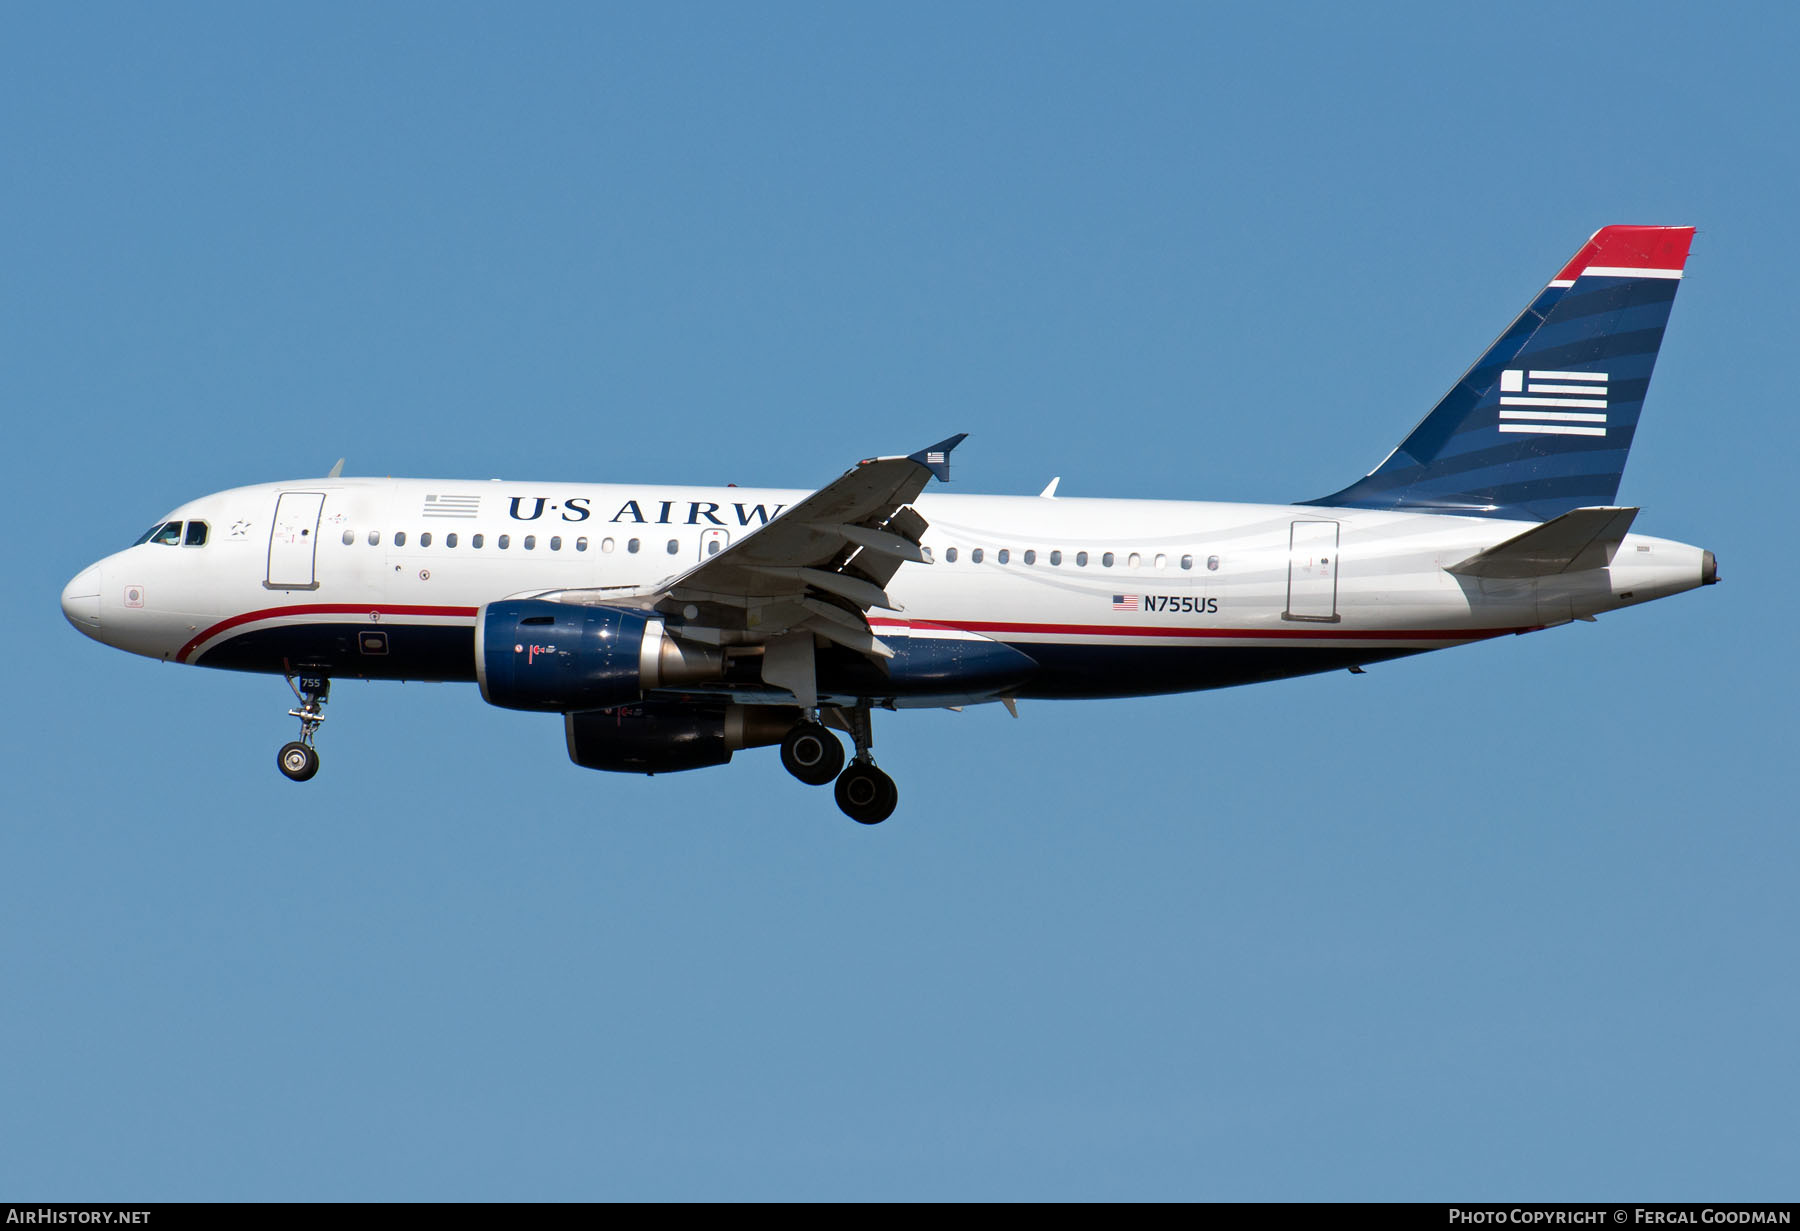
[0,4,1800,1200]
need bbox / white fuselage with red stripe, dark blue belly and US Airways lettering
[63,479,1710,704]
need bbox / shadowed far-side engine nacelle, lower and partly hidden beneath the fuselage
[563,702,801,774]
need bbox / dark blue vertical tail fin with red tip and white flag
[1303,227,1694,522]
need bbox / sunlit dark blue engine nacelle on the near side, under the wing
[475,599,724,713]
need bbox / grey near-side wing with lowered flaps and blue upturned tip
[525,432,967,687]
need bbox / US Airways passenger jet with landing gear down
[61,227,1719,824]
